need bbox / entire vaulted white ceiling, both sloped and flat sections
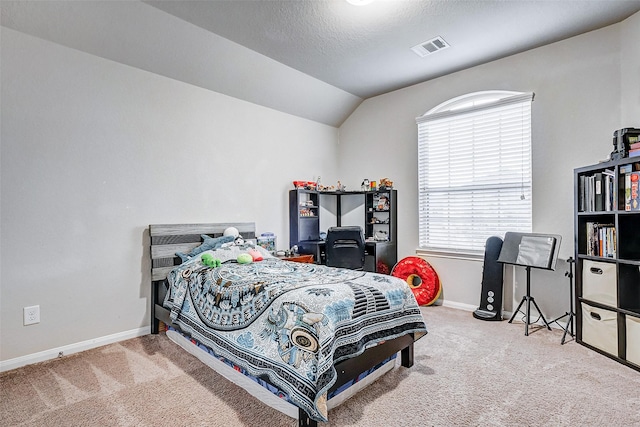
[0,0,640,126]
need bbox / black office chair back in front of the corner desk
[325,226,364,270]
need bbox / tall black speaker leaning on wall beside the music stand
[473,236,504,320]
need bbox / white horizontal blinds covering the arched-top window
[416,92,533,254]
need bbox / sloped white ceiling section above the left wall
[0,0,362,126]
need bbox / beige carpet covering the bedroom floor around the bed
[0,307,640,427]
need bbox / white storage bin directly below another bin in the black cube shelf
[582,303,618,357]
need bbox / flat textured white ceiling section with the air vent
[145,0,640,98]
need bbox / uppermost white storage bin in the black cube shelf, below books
[582,260,618,307]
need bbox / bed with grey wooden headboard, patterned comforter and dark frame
[149,223,427,426]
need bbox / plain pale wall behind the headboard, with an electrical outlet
[0,27,338,362]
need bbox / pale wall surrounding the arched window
[339,14,640,318]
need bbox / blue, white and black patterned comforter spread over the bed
[164,251,427,421]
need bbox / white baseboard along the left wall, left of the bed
[0,326,151,372]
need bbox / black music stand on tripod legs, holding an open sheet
[498,232,562,336]
